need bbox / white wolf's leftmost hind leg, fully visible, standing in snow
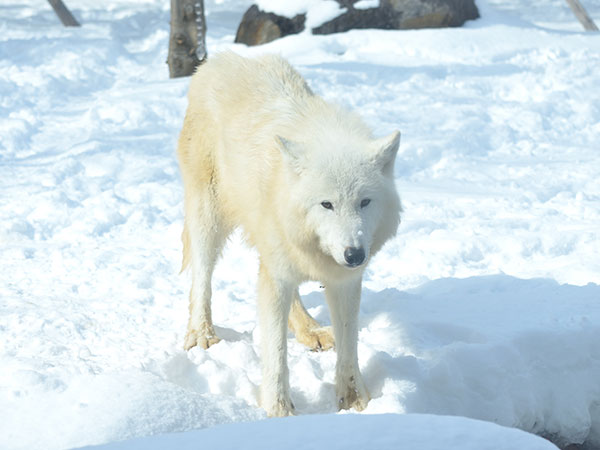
[182,185,229,350]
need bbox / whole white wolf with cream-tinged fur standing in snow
[177,53,401,416]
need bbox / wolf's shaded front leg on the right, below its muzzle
[325,278,371,411]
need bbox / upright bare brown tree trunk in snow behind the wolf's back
[167,0,206,78]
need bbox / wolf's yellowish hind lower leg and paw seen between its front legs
[288,289,335,351]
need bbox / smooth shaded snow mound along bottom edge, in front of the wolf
[79,414,556,450]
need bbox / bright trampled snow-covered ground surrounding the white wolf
[0,0,600,449]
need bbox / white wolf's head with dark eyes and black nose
[279,128,400,270]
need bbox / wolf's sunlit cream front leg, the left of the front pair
[258,263,296,417]
